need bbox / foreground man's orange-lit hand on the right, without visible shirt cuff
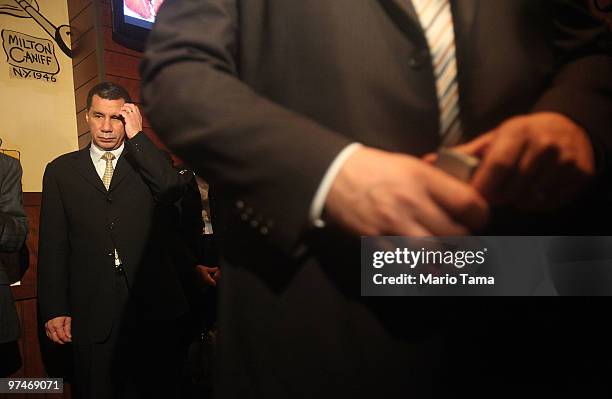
[456,113,595,211]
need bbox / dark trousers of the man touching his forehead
[73,273,187,399]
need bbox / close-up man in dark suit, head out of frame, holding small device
[142,0,612,397]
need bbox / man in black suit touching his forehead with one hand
[38,83,187,398]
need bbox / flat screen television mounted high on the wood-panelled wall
[111,0,164,51]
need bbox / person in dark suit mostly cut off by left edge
[0,153,28,376]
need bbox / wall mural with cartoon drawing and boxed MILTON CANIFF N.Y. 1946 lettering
[0,0,72,83]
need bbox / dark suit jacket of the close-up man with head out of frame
[142,0,612,397]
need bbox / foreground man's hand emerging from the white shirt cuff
[325,147,488,236]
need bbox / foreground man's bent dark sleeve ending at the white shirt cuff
[142,0,350,254]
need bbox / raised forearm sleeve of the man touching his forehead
[126,132,186,205]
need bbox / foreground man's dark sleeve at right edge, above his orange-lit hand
[534,0,612,178]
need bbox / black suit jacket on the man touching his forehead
[38,133,186,343]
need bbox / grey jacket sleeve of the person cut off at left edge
[0,156,28,252]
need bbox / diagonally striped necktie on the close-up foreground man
[412,0,462,147]
